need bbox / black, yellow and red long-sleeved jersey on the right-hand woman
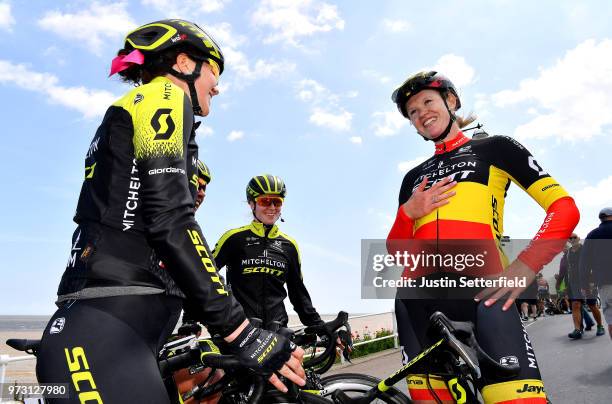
[388,132,579,271]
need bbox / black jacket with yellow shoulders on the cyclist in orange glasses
[213,220,321,325]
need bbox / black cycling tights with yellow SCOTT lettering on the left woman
[36,294,182,403]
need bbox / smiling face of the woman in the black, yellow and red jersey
[406,89,457,139]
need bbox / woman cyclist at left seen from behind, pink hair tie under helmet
[37,20,304,403]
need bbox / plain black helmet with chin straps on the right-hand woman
[391,70,461,142]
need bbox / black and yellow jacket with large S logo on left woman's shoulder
[58,77,245,334]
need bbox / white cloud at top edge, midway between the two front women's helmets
[251,0,344,46]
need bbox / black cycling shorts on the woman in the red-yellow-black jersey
[395,299,542,385]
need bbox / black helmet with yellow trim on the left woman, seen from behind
[120,19,225,115]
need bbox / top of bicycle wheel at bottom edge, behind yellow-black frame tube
[321,373,412,404]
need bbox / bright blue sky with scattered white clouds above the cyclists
[0,0,612,314]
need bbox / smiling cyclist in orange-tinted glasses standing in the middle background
[213,174,322,328]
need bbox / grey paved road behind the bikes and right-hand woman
[331,315,612,404]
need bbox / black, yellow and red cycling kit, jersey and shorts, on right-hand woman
[387,132,579,404]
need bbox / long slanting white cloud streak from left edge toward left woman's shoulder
[0,60,117,118]
